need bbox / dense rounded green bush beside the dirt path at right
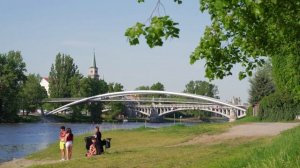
[258,92,300,121]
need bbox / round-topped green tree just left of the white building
[19,74,48,115]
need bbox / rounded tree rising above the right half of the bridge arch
[183,80,219,98]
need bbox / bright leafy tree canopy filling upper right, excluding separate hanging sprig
[191,0,300,79]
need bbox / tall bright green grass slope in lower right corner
[222,127,300,168]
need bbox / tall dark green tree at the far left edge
[0,51,26,122]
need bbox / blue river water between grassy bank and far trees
[0,122,188,163]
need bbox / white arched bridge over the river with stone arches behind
[44,90,246,121]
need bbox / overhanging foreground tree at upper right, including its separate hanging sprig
[125,0,300,97]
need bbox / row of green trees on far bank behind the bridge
[0,51,218,122]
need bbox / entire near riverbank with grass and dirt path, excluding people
[0,123,300,167]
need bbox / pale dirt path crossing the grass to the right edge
[176,123,300,146]
